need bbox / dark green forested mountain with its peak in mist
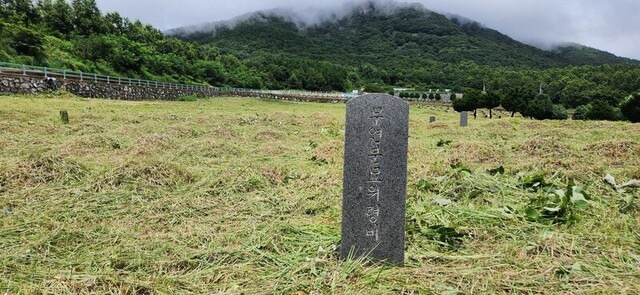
[170,2,637,69]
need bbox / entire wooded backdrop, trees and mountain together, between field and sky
[0,0,640,119]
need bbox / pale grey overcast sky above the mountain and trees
[97,0,640,59]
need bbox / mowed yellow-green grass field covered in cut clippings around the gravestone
[0,95,640,294]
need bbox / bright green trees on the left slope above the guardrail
[0,0,263,88]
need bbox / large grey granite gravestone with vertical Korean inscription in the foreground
[340,94,409,266]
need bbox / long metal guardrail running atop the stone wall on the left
[0,62,358,100]
